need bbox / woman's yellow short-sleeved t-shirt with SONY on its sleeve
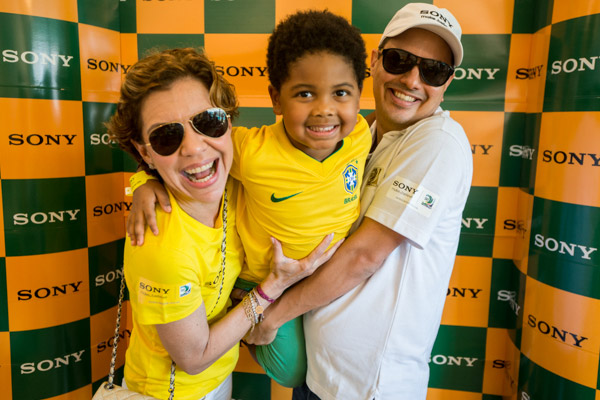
[124,180,243,399]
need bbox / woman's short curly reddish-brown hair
[105,48,238,176]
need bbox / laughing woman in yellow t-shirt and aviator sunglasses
[107,49,333,399]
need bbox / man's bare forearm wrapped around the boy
[246,218,406,344]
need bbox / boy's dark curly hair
[267,10,367,90]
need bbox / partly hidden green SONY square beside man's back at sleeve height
[458,186,498,257]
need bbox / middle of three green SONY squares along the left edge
[2,177,87,256]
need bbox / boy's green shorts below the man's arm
[235,278,306,387]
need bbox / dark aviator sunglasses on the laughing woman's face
[146,107,229,156]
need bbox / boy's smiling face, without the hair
[269,51,360,161]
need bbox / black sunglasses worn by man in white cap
[380,49,454,86]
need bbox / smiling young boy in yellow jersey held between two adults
[127,11,372,387]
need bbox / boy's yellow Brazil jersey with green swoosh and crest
[231,115,371,282]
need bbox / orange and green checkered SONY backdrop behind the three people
[0,0,600,400]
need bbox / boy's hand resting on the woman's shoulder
[126,179,171,246]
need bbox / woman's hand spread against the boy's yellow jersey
[261,233,344,299]
